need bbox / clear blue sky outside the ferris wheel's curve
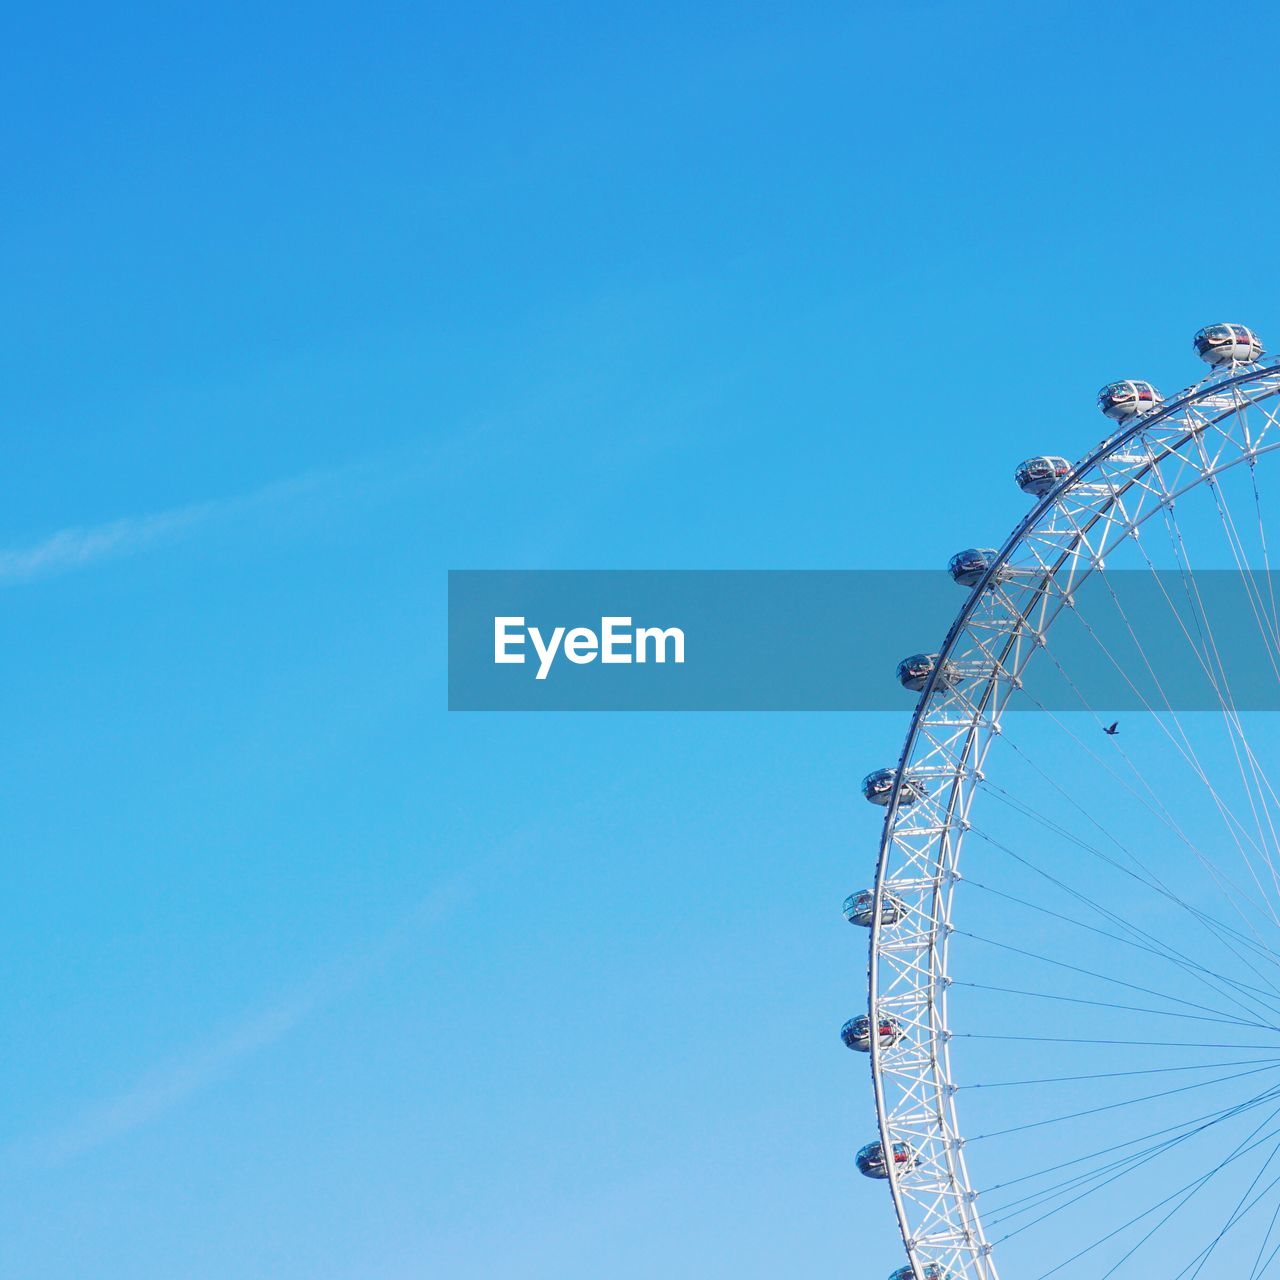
[0,3,1280,1280]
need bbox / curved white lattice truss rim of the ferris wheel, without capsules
[868,358,1280,1280]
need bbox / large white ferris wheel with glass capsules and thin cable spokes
[841,324,1280,1280]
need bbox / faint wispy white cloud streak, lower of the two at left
[0,878,472,1172]
